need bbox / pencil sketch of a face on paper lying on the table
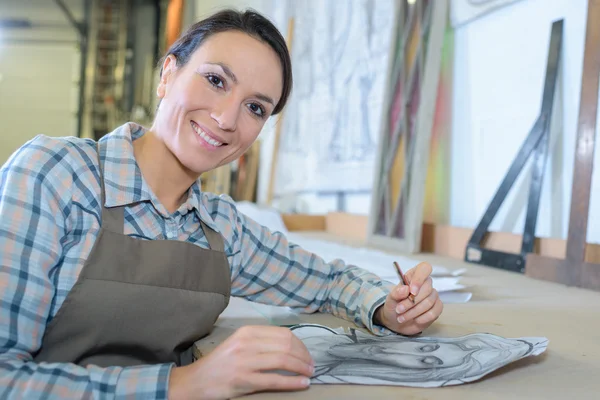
[290,324,548,387]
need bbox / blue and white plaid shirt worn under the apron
[0,123,392,399]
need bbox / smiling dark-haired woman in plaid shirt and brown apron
[0,7,442,399]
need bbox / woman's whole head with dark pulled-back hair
[139,11,293,208]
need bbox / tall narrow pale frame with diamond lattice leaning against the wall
[367,0,449,253]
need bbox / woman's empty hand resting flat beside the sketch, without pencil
[169,326,314,400]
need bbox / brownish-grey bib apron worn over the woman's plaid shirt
[34,145,231,367]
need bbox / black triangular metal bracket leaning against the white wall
[465,19,563,273]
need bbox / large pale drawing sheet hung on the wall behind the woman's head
[275,0,395,197]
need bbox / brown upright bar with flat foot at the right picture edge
[525,0,600,290]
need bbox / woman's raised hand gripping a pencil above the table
[375,263,444,335]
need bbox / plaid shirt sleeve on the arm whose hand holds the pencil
[218,197,394,334]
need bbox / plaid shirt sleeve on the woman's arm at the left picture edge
[0,137,171,399]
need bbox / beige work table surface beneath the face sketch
[196,233,600,400]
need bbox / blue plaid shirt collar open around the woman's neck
[99,122,208,220]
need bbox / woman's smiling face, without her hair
[152,31,283,175]
